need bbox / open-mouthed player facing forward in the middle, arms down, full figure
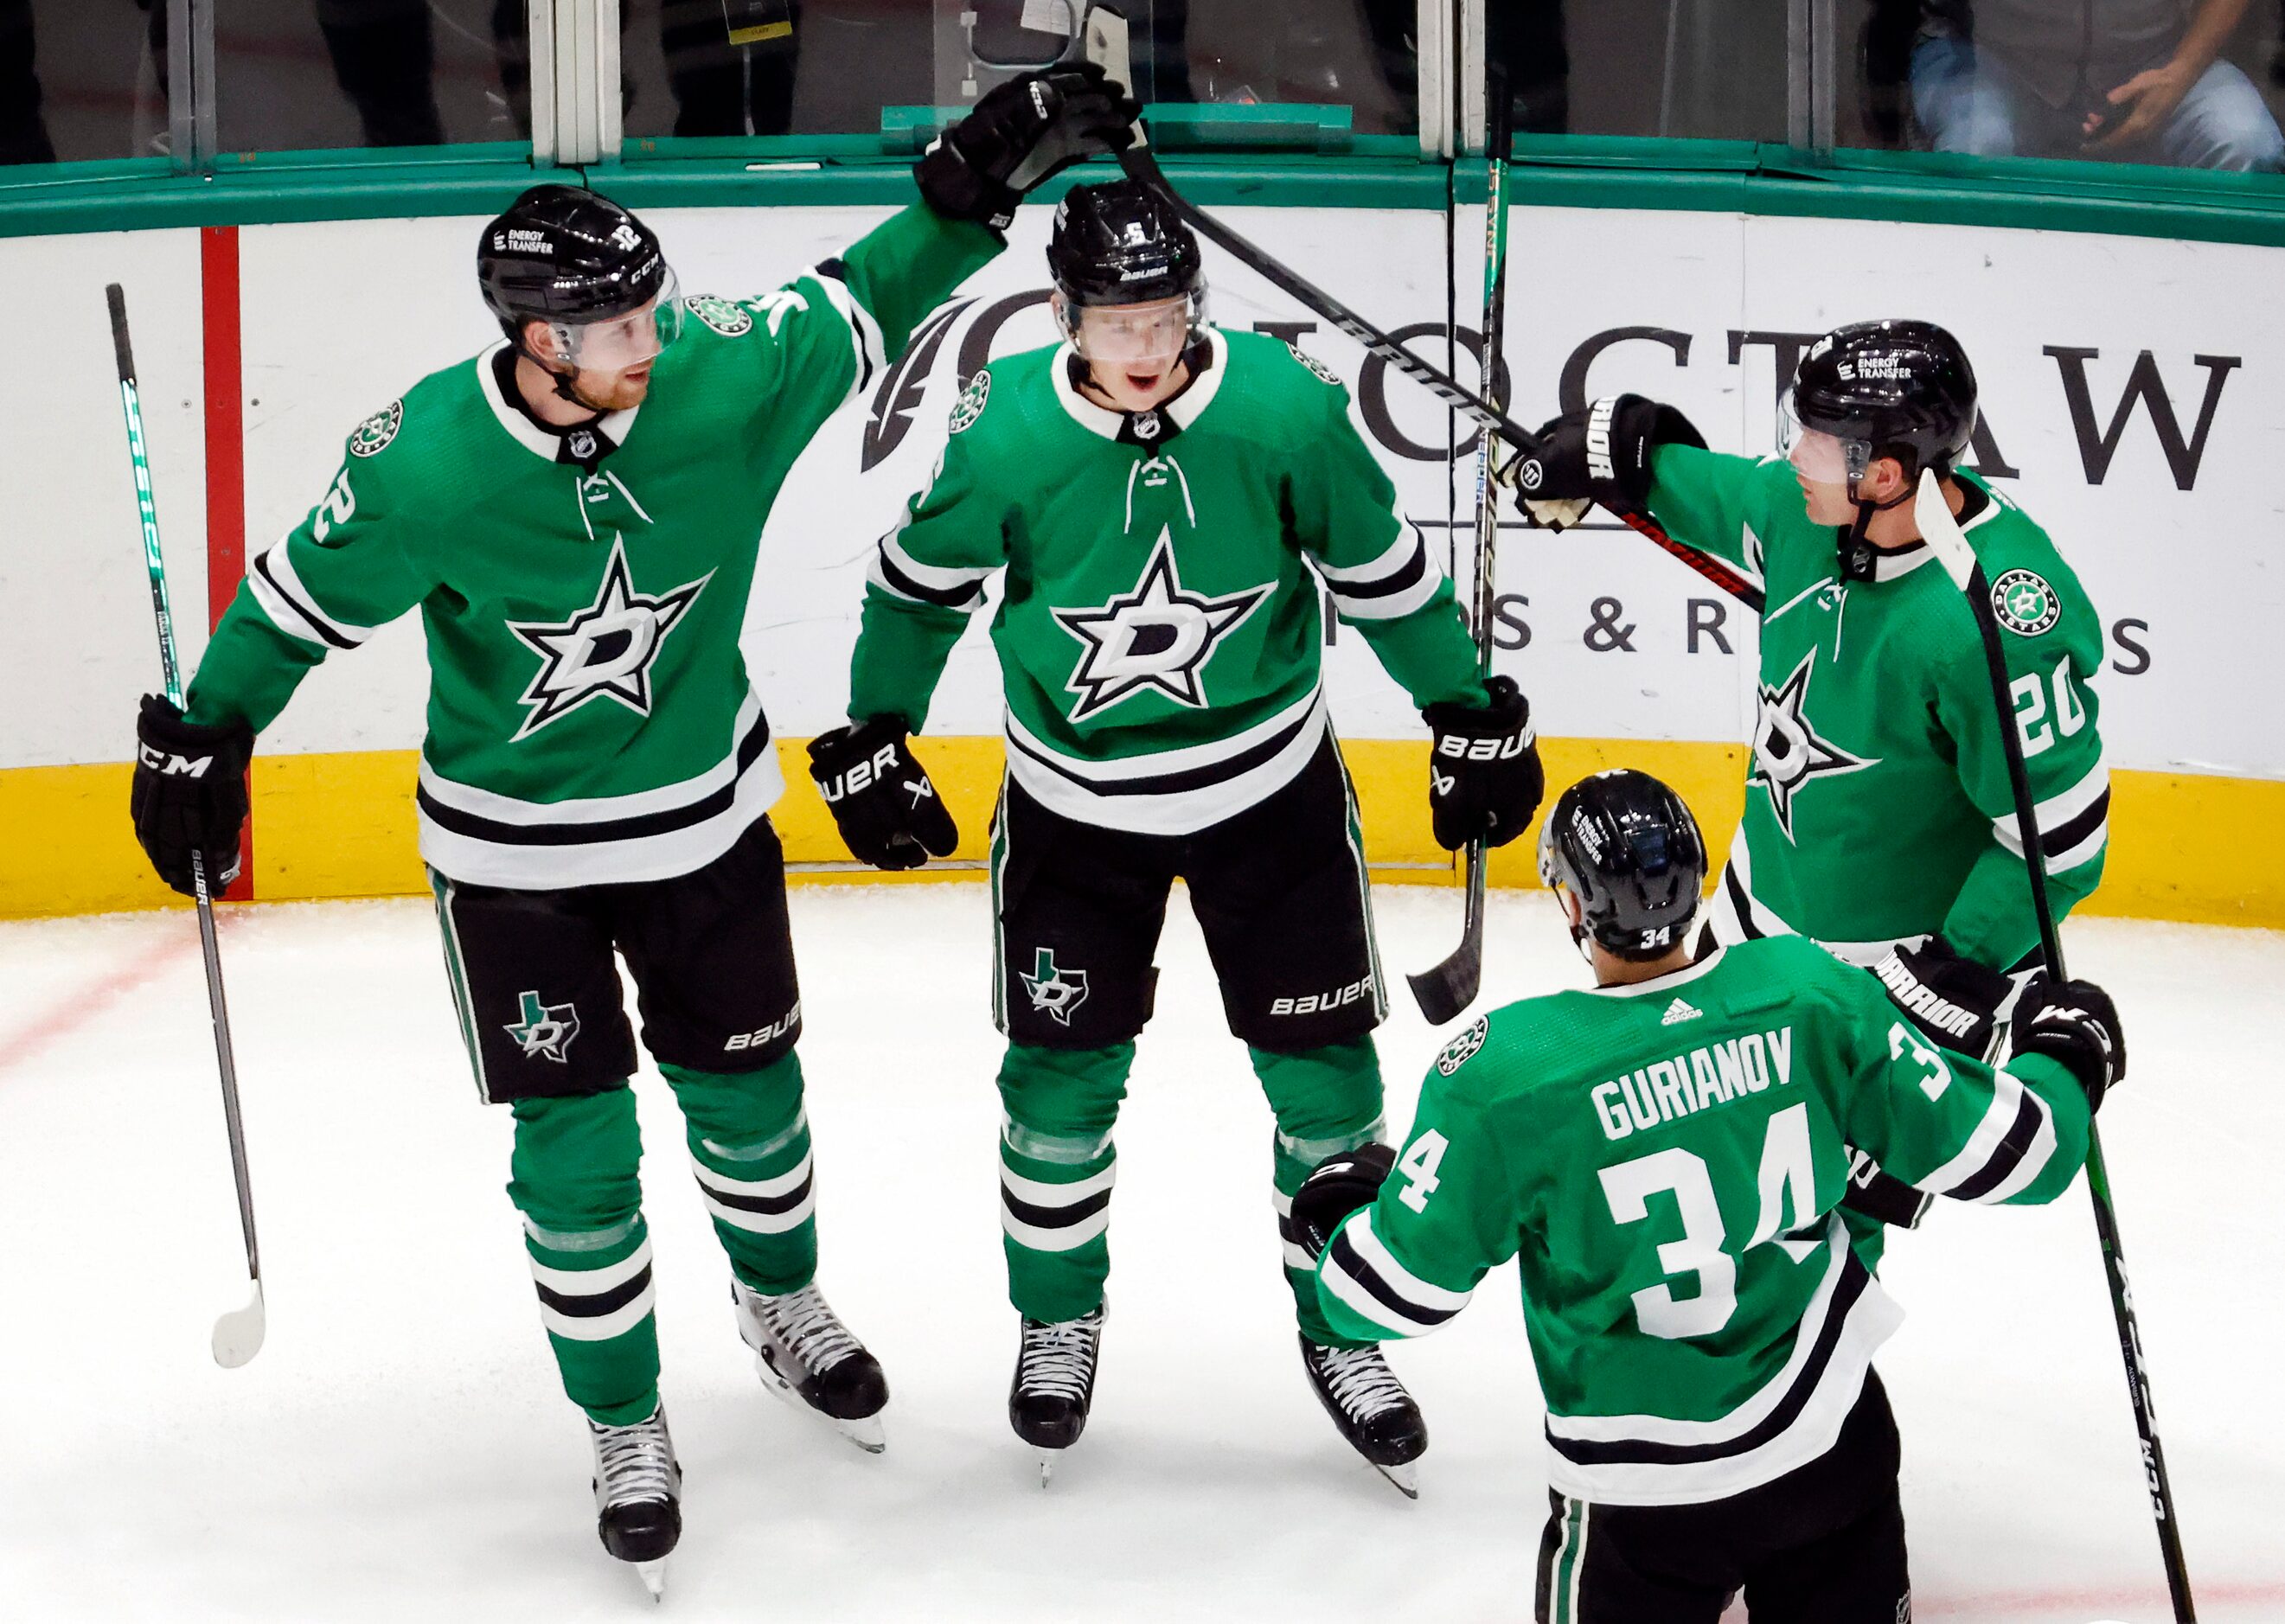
[811,182,1540,1492]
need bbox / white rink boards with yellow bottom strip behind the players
[0,208,2285,925]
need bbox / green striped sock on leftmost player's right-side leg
[658,1053,818,1295]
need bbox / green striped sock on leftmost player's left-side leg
[508,1083,658,1428]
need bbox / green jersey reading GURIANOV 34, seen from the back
[1318,937,2089,1506]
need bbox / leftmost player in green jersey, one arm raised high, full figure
[120,71,1133,1589]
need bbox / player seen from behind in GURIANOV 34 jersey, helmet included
[1293,772,2125,1624]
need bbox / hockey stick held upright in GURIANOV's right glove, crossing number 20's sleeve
[1912,468,2199,1624]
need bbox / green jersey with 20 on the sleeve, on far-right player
[1650,445,2111,971]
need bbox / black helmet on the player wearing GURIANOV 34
[1540,767,1707,959]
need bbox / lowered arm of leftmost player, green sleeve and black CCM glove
[132,420,437,895]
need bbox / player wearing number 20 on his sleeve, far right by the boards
[1506,322,2111,1222]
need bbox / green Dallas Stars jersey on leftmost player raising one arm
[189,206,1001,888]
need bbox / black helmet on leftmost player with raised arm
[476,185,674,349]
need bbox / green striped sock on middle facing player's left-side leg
[999,1044,1136,1320]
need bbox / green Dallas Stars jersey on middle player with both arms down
[850,329,1483,834]
